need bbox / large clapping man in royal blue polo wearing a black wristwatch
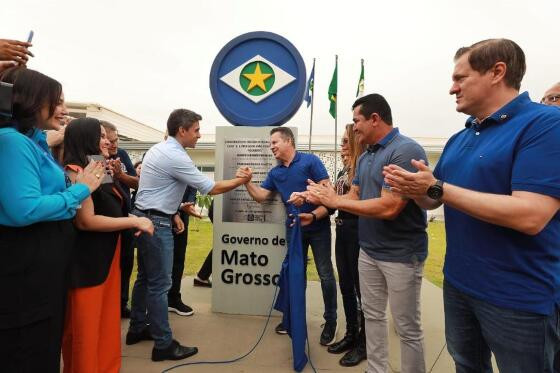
[385,39,560,373]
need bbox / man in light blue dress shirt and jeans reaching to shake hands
[126,109,250,361]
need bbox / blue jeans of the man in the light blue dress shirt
[129,210,173,349]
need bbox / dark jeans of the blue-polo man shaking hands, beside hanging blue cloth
[298,227,336,321]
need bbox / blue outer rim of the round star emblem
[210,31,307,127]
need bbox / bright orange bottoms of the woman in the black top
[62,236,121,373]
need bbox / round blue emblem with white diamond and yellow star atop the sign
[210,31,306,127]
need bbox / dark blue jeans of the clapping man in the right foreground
[443,280,560,373]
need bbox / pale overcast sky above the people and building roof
[0,0,560,137]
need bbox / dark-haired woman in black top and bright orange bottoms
[62,118,154,373]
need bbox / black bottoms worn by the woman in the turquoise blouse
[0,220,75,373]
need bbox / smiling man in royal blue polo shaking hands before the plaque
[245,127,337,346]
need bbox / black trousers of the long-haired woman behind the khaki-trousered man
[334,219,364,333]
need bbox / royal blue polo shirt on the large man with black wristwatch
[434,92,560,315]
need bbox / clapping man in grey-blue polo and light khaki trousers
[307,94,428,373]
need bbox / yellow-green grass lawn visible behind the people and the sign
[130,218,445,290]
